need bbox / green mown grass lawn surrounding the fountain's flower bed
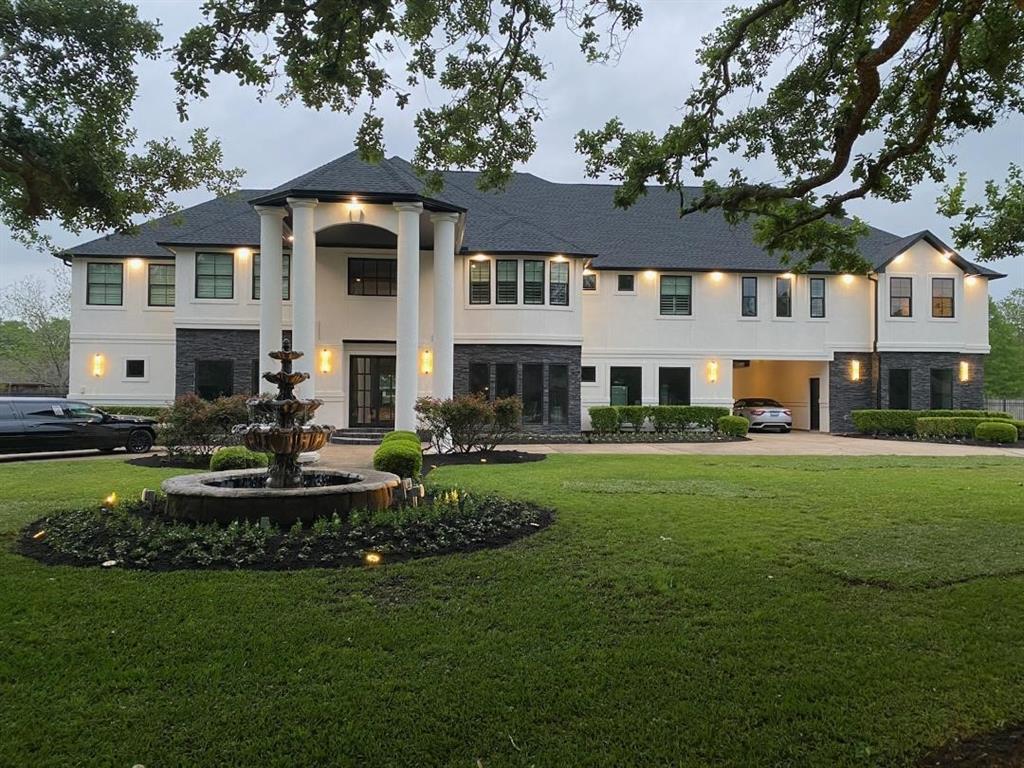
[0,456,1024,768]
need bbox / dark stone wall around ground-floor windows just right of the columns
[454,344,581,434]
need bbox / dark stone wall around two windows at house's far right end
[879,352,985,411]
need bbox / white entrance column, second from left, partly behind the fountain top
[288,198,317,397]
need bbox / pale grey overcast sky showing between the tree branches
[0,0,1024,297]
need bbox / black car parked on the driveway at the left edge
[0,397,157,454]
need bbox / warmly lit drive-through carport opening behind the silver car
[732,360,828,432]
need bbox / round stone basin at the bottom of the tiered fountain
[161,469,401,525]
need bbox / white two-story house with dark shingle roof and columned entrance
[62,154,1001,432]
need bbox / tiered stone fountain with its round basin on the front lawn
[162,340,400,525]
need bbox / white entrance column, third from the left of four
[394,203,423,429]
